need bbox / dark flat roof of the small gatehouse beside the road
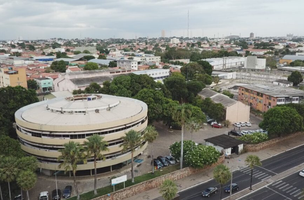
[205,134,244,149]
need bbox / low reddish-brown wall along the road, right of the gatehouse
[244,132,304,152]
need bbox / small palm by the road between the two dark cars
[213,164,231,199]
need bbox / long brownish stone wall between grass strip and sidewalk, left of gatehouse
[93,156,225,200]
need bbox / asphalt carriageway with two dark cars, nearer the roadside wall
[179,146,304,200]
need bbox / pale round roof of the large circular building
[15,94,148,130]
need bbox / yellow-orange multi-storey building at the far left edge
[0,67,27,88]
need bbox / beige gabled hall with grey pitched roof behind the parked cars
[198,88,250,123]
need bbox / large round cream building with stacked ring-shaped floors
[15,94,148,175]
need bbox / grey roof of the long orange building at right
[241,85,304,97]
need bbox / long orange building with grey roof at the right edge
[238,85,304,112]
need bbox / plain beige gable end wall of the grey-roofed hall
[226,101,250,123]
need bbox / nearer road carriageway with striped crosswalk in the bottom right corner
[241,173,304,200]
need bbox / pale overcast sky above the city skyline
[0,0,304,40]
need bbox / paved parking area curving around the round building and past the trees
[30,115,261,198]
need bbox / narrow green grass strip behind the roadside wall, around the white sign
[70,164,179,200]
